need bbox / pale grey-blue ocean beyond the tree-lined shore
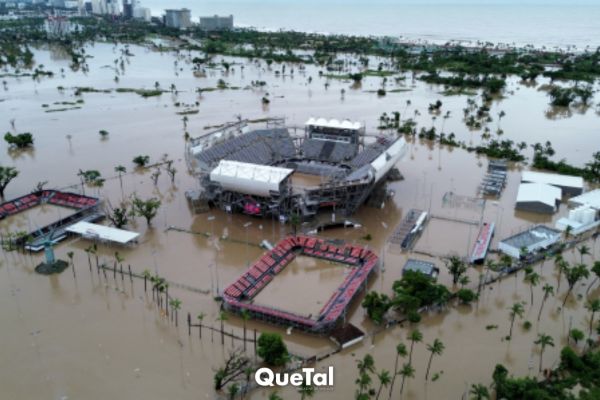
[141,0,600,50]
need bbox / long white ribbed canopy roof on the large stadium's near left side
[210,160,294,196]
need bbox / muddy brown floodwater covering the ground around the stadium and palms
[0,44,600,400]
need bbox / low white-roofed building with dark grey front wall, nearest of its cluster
[515,183,562,214]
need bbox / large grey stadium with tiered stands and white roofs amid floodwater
[186,118,406,220]
